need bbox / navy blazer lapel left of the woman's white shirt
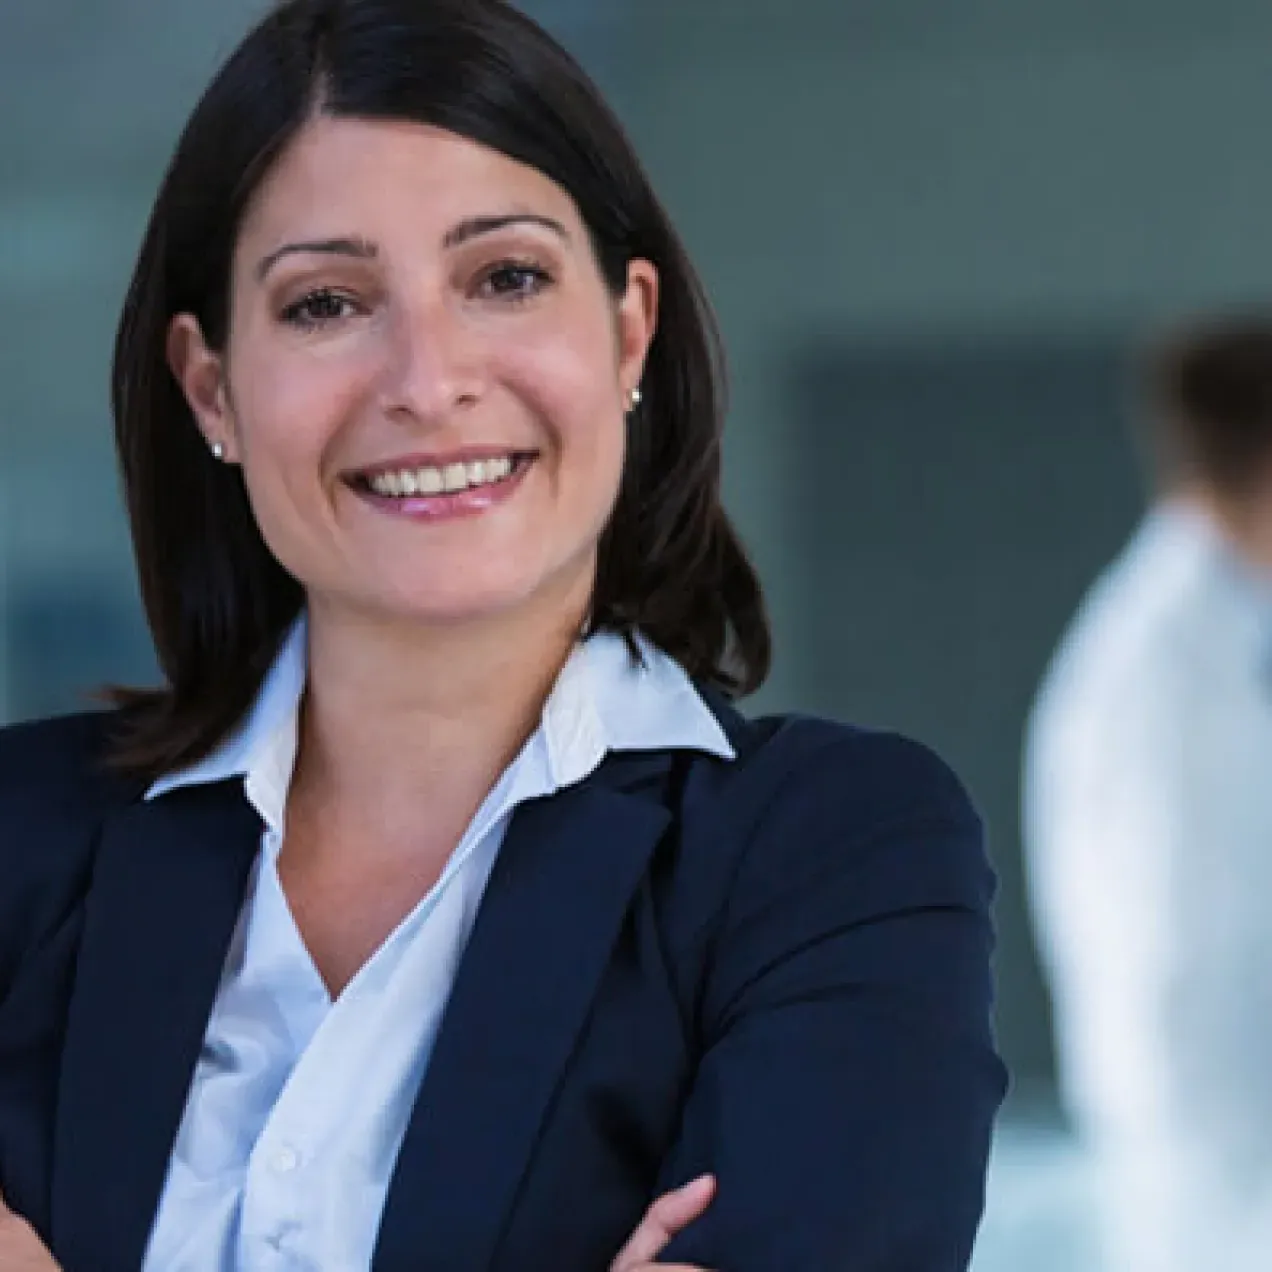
[52,782,261,1272]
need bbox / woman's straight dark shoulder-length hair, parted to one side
[112,0,770,776]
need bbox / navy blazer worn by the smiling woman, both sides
[0,698,1005,1272]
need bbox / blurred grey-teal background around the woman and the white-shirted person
[7,0,1272,1272]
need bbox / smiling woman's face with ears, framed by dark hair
[169,118,658,622]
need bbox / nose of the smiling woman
[382,300,485,424]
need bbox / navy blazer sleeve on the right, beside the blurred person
[660,730,1005,1272]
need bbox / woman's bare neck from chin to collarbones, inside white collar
[293,580,585,820]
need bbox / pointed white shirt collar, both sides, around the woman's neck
[145,617,734,829]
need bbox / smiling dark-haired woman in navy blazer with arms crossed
[0,0,1002,1272]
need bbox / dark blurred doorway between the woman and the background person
[794,336,1142,1095]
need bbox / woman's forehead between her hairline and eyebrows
[239,117,579,243]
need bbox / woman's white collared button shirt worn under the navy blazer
[142,623,733,1272]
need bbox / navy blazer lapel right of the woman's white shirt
[373,754,670,1272]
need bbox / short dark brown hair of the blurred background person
[1149,314,1272,496]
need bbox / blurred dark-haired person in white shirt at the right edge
[1023,317,1272,1272]
